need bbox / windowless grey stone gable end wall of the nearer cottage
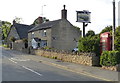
[51,19,81,51]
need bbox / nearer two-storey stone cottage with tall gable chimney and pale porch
[28,6,81,51]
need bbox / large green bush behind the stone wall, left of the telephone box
[78,35,100,55]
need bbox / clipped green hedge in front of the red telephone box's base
[100,51,120,66]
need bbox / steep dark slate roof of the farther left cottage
[13,23,34,39]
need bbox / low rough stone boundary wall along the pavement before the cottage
[32,49,99,66]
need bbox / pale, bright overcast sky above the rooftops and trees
[0,0,120,34]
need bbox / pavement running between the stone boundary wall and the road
[2,50,120,81]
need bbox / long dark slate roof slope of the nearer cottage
[28,19,64,32]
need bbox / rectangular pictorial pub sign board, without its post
[76,10,91,23]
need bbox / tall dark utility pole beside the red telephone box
[112,0,116,50]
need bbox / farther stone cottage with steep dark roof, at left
[7,21,33,51]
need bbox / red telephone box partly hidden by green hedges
[100,32,112,53]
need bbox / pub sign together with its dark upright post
[76,10,91,37]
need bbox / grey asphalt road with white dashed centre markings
[2,49,115,81]
